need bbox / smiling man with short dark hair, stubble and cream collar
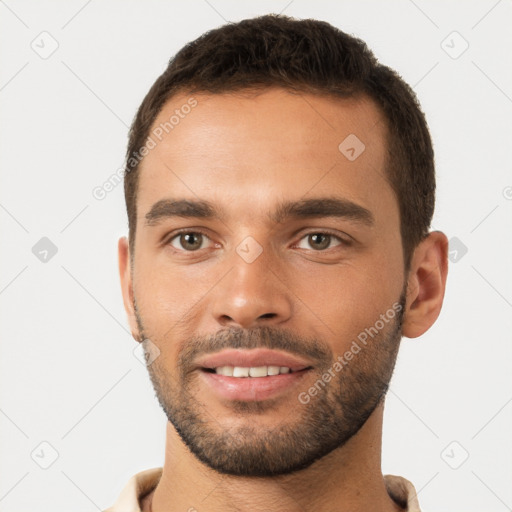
[108,15,448,512]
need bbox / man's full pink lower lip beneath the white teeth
[201,369,309,402]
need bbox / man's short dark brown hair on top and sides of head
[124,14,435,270]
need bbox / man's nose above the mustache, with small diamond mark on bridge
[213,245,293,329]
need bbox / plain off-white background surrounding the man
[0,0,512,512]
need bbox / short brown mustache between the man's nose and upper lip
[178,326,334,371]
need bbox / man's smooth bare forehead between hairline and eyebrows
[138,88,397,226]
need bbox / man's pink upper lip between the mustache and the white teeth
[196,349,311,372]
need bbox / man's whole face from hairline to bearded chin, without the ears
[120,88,406,476]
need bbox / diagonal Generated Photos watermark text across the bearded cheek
[297,302,402,405]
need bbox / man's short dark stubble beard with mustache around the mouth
[135,291,405,477]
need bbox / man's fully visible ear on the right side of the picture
[402,231,448,338]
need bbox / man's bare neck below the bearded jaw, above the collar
[144,404,403,512]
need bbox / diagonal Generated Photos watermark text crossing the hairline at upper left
[92,97,198,201]
